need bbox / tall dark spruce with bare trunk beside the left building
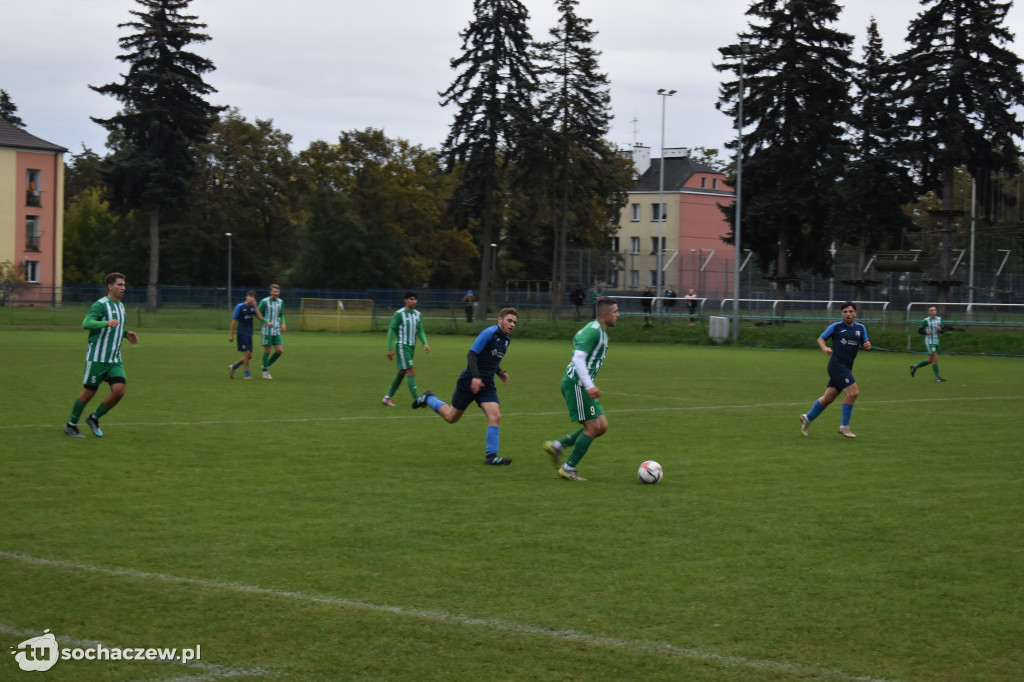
[90,0,219,311]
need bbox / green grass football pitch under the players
[0,330,1024,682]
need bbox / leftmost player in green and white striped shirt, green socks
[65,272,138,438]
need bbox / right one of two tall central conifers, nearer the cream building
[532,0,631,296]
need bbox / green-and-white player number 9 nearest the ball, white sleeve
[544,296,618,480]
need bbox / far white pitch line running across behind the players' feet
[0,393,1024,430]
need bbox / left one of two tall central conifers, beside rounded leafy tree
[439,0,538,305]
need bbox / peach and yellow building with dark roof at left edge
[0,119,68,303]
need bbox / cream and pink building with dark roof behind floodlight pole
[615,146,735,299]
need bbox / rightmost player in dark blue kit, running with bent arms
[800,301,871,438]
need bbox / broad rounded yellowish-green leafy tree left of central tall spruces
[292,129,479,289]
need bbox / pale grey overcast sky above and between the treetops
[6,0,1024,156]
